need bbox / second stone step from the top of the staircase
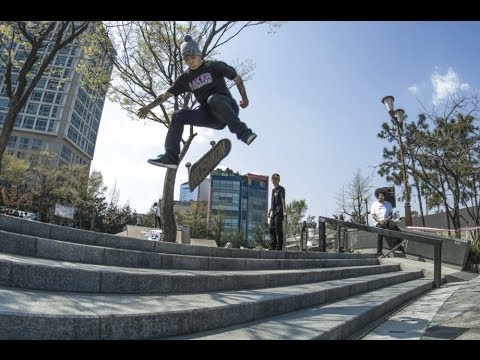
[0,231,378,270]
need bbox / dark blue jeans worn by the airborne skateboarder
[165,94,252,160]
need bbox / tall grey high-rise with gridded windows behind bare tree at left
[0,22,112,167]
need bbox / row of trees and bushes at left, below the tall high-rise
[0,151,141,234]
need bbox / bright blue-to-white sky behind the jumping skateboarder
[91,21,480,217]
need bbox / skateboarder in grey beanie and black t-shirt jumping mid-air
[137,35,257,169]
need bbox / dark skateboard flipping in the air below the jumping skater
[186,139,232,192]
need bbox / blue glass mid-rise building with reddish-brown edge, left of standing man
[208,174,268,241]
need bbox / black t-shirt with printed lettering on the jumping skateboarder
[167,60,237,105]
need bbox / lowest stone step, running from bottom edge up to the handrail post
[174,279,432,340]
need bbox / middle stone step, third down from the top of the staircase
[0,253,400,294]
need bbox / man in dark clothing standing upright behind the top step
[268,173,287,250]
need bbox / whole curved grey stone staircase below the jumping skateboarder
[0,215,433,339]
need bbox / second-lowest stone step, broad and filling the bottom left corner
[0,271,424,340]
